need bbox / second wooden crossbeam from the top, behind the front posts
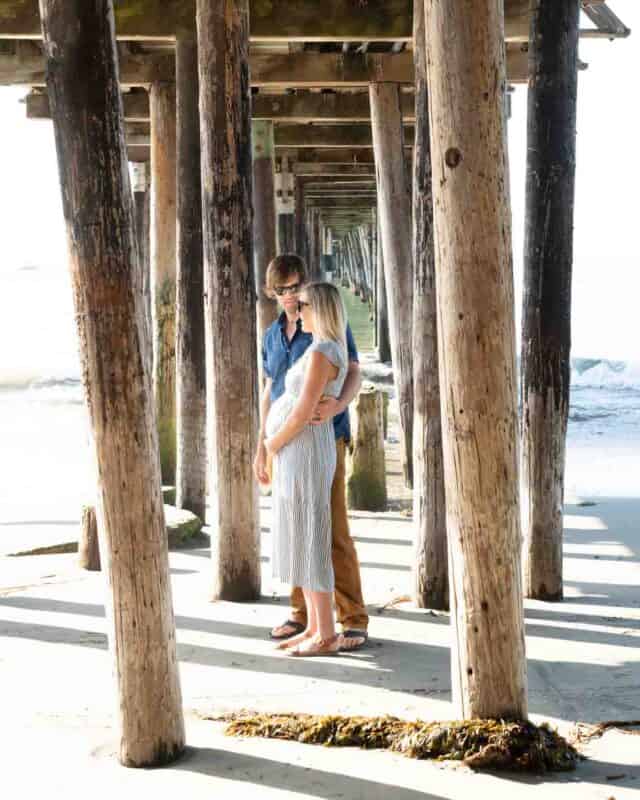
[0,40,528,89]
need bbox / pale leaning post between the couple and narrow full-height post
[369,83,413,486]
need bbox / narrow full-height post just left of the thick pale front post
[413,1,449,610]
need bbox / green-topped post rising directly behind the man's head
[251,120,278,339]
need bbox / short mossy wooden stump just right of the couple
[347,384,387,511]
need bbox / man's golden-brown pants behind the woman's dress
[291,439,369,630]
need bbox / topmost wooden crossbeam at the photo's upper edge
[0,0,529,42]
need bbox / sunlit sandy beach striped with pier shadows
[0,378,640,800]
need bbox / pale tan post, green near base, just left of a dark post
[149,83,176,484]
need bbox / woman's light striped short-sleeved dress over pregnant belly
[266,341,347,592]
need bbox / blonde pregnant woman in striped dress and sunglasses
[265,283,348,656]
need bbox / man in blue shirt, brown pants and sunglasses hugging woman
[253,254,369,650]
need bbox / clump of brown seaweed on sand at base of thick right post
[220,712,581,772]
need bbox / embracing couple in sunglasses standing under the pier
[254,254,368,657]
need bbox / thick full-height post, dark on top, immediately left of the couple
[197,0,260,601]
